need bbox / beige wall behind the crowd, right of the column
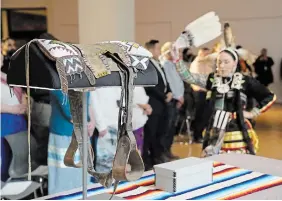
[135,0,282,102]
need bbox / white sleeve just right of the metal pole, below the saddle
[90,91,108,132]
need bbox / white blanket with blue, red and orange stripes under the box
[47,162,282,200]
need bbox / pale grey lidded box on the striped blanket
[154,157,213,193]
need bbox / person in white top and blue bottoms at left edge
[0,68,28,182]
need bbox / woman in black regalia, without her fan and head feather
[177,48,276,157]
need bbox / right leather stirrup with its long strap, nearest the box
[107,52,144,199]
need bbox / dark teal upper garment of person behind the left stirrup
[50,90,90,136]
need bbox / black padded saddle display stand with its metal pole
[7,39,157,200]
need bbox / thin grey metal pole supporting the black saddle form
[82,92,88,200]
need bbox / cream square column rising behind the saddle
[78,0,135,43]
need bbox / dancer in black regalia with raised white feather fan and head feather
[167,12,276,157]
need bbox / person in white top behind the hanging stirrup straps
[91,87,152,172]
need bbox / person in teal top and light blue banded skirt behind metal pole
[48,90,95,194]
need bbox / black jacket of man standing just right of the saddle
[145,61,171,115]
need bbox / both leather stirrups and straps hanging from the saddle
[64,52,144,196]
